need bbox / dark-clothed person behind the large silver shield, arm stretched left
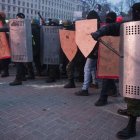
[91,2,140,139]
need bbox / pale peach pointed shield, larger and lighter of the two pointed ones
[76,19,97,57]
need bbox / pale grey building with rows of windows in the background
[0,0,82,20]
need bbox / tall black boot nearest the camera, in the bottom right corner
[117,116,137,139]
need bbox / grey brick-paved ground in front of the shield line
[0,68,140,140]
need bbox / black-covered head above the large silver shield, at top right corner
[132,2,140,21]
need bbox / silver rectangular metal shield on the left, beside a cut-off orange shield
[9,19,33,62]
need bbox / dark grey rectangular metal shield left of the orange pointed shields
[41,26,60,65]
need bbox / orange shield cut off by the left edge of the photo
[0,21,11,59]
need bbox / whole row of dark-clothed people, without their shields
[0,3,140,139]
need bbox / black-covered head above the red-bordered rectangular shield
[106,11,117,23]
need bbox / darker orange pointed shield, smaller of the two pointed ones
[59,30,78,61]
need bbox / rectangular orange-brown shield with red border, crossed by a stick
[97,36,120,79]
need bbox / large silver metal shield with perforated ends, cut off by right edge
[121,21,140,99]
